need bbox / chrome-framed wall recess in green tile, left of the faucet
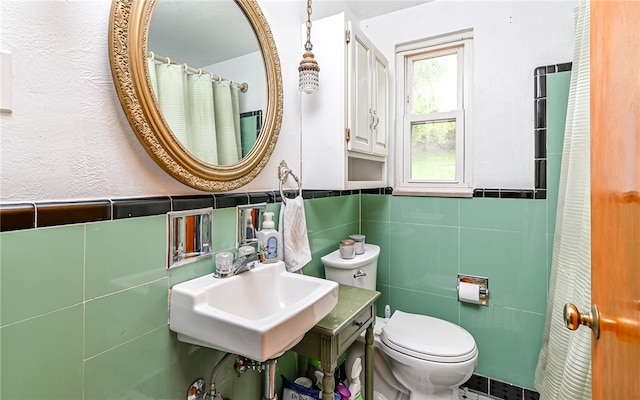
[167,208,213,268]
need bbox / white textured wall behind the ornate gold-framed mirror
[0,0,305,203]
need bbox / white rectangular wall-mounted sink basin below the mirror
[169,261,338,361]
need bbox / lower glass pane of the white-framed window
[411,120,456,181]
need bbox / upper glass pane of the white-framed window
[412,54,458,114]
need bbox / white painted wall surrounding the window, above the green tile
[361,0,579,189]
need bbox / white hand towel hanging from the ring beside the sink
[278,196,311,272]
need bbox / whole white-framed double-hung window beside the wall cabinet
[394,31,473,196]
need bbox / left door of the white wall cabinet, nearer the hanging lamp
[347,21,373,154]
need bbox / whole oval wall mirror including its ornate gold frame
[109,0,282,192]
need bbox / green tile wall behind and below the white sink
[0,196,360,400]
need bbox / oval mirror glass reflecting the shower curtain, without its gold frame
[147,0,267,166]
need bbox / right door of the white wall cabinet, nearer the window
[371,48,389,156]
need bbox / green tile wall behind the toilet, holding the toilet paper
[360,72,571,389]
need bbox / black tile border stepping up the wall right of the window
[473,62,573,199]
